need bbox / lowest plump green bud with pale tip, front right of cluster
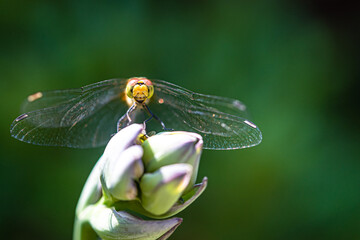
[140,163,192,215]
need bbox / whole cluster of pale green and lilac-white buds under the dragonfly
[74,124,207,240]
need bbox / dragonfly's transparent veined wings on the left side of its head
[10,79,128,148]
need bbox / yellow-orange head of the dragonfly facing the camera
[126,77,154,103]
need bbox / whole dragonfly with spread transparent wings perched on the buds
[10,77,262,150]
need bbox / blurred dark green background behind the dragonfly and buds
[0,0,360,240]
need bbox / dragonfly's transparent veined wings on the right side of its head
[149,80,262,149]
